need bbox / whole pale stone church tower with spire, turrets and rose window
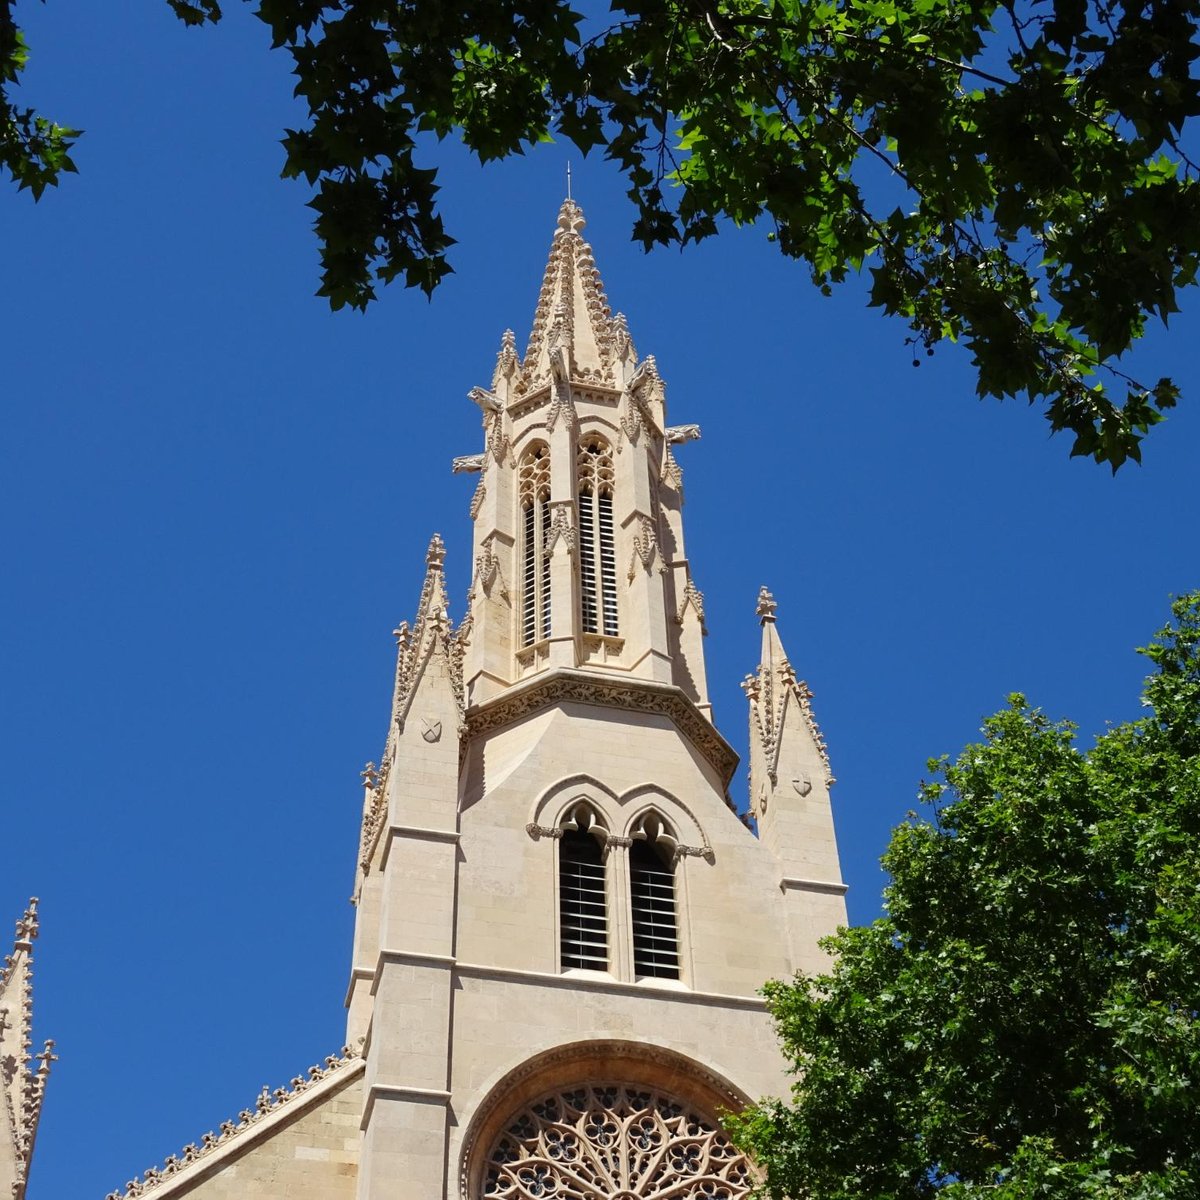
[96,200,845,1200]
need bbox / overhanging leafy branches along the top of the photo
[0,0,1200,470]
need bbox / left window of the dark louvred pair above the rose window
[558,803,608,971]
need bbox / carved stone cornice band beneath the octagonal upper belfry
[466,667,738,792]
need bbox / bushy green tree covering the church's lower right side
[732,592,1200,1200]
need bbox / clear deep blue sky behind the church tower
[7,0,1200,1200]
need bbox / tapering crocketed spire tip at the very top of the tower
[518,199,629,391]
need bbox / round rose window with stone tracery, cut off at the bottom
[484,1084,754,1200]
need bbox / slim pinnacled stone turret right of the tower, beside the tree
[742,588,846,973]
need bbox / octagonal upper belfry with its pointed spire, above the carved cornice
[452,199,712,720]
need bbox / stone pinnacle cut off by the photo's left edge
[0,898,54,1200]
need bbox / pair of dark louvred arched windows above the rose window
[558,800,679,979]
